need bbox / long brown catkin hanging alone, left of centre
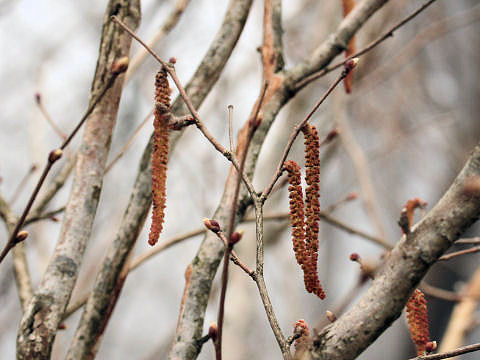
[148,67,170,246]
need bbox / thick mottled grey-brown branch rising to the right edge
[310,145,480,360]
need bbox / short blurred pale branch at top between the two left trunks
[125,0,190,82]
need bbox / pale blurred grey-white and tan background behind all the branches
[0,0,480,360]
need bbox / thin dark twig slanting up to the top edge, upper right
[297,0,437,88]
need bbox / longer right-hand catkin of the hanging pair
[302,123,325,299]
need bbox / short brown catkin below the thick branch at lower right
[406,289,430,356]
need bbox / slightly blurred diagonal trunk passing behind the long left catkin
[63,0,251,356]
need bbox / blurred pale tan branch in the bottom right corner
[438,267,480,353]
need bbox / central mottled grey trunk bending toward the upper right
[169,0,388,359]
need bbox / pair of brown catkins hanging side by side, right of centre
[284,123,325,299]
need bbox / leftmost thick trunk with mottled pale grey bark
[17,0,140,359]
